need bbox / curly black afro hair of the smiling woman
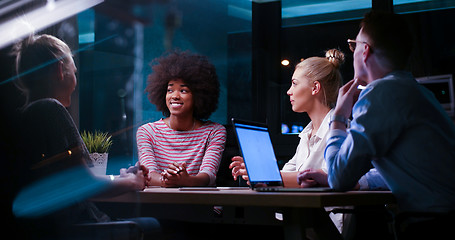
[145,51,220,120]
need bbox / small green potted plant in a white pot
[81,131,112,175]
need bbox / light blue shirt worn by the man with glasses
[325,72,455,212]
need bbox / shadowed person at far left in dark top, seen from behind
[14,34,161,239]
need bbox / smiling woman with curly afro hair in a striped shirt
[136,51,226,187]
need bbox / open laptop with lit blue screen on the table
[232,118,332,192]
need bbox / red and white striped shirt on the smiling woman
[136,119,226,185]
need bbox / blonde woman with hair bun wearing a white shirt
[229,49,344,187]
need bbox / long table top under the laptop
[94,187,396,208]
